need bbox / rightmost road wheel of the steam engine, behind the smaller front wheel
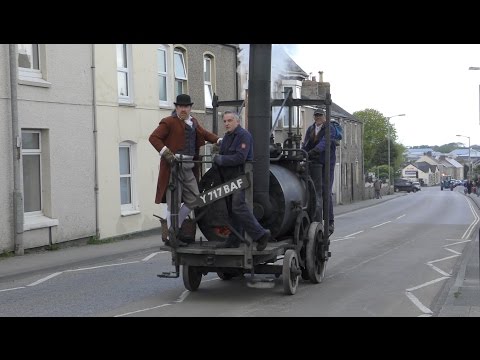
[306,222,327,284]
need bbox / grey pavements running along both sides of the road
[0,192,480,317]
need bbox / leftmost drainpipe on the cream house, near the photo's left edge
[8,44,24,255]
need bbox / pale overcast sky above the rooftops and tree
[276,44,480,146]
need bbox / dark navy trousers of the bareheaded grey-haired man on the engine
[227,190,265,241]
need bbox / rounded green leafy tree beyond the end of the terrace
[353,109,398,171]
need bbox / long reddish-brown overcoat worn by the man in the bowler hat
[148,115,218,204]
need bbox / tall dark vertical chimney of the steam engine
[247,44,272,220]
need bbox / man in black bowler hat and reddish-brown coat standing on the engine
[149,94,222,233]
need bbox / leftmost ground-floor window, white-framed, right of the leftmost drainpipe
[22,130,42,215]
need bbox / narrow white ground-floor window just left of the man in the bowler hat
[119,142,139,216]
